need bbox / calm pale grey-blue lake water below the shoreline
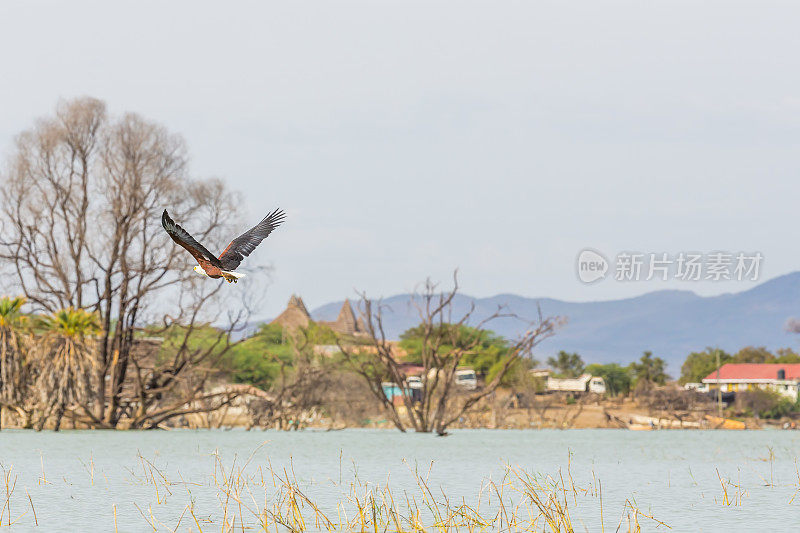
[0,430,800,532]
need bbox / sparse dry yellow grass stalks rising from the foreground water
[14,443,800,533]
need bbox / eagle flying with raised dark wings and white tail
[161,209,286,283]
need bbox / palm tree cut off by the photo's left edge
[0,296,30,428]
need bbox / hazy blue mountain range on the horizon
[311,272,800,370]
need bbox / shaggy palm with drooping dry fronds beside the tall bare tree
[36,307,101,431]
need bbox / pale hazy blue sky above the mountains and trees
[0,0,800,316]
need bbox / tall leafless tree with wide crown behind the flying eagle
[0,98,255,428]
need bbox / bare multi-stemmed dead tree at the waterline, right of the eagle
[339,273,561,435]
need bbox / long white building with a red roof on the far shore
[703,363,800,400]
